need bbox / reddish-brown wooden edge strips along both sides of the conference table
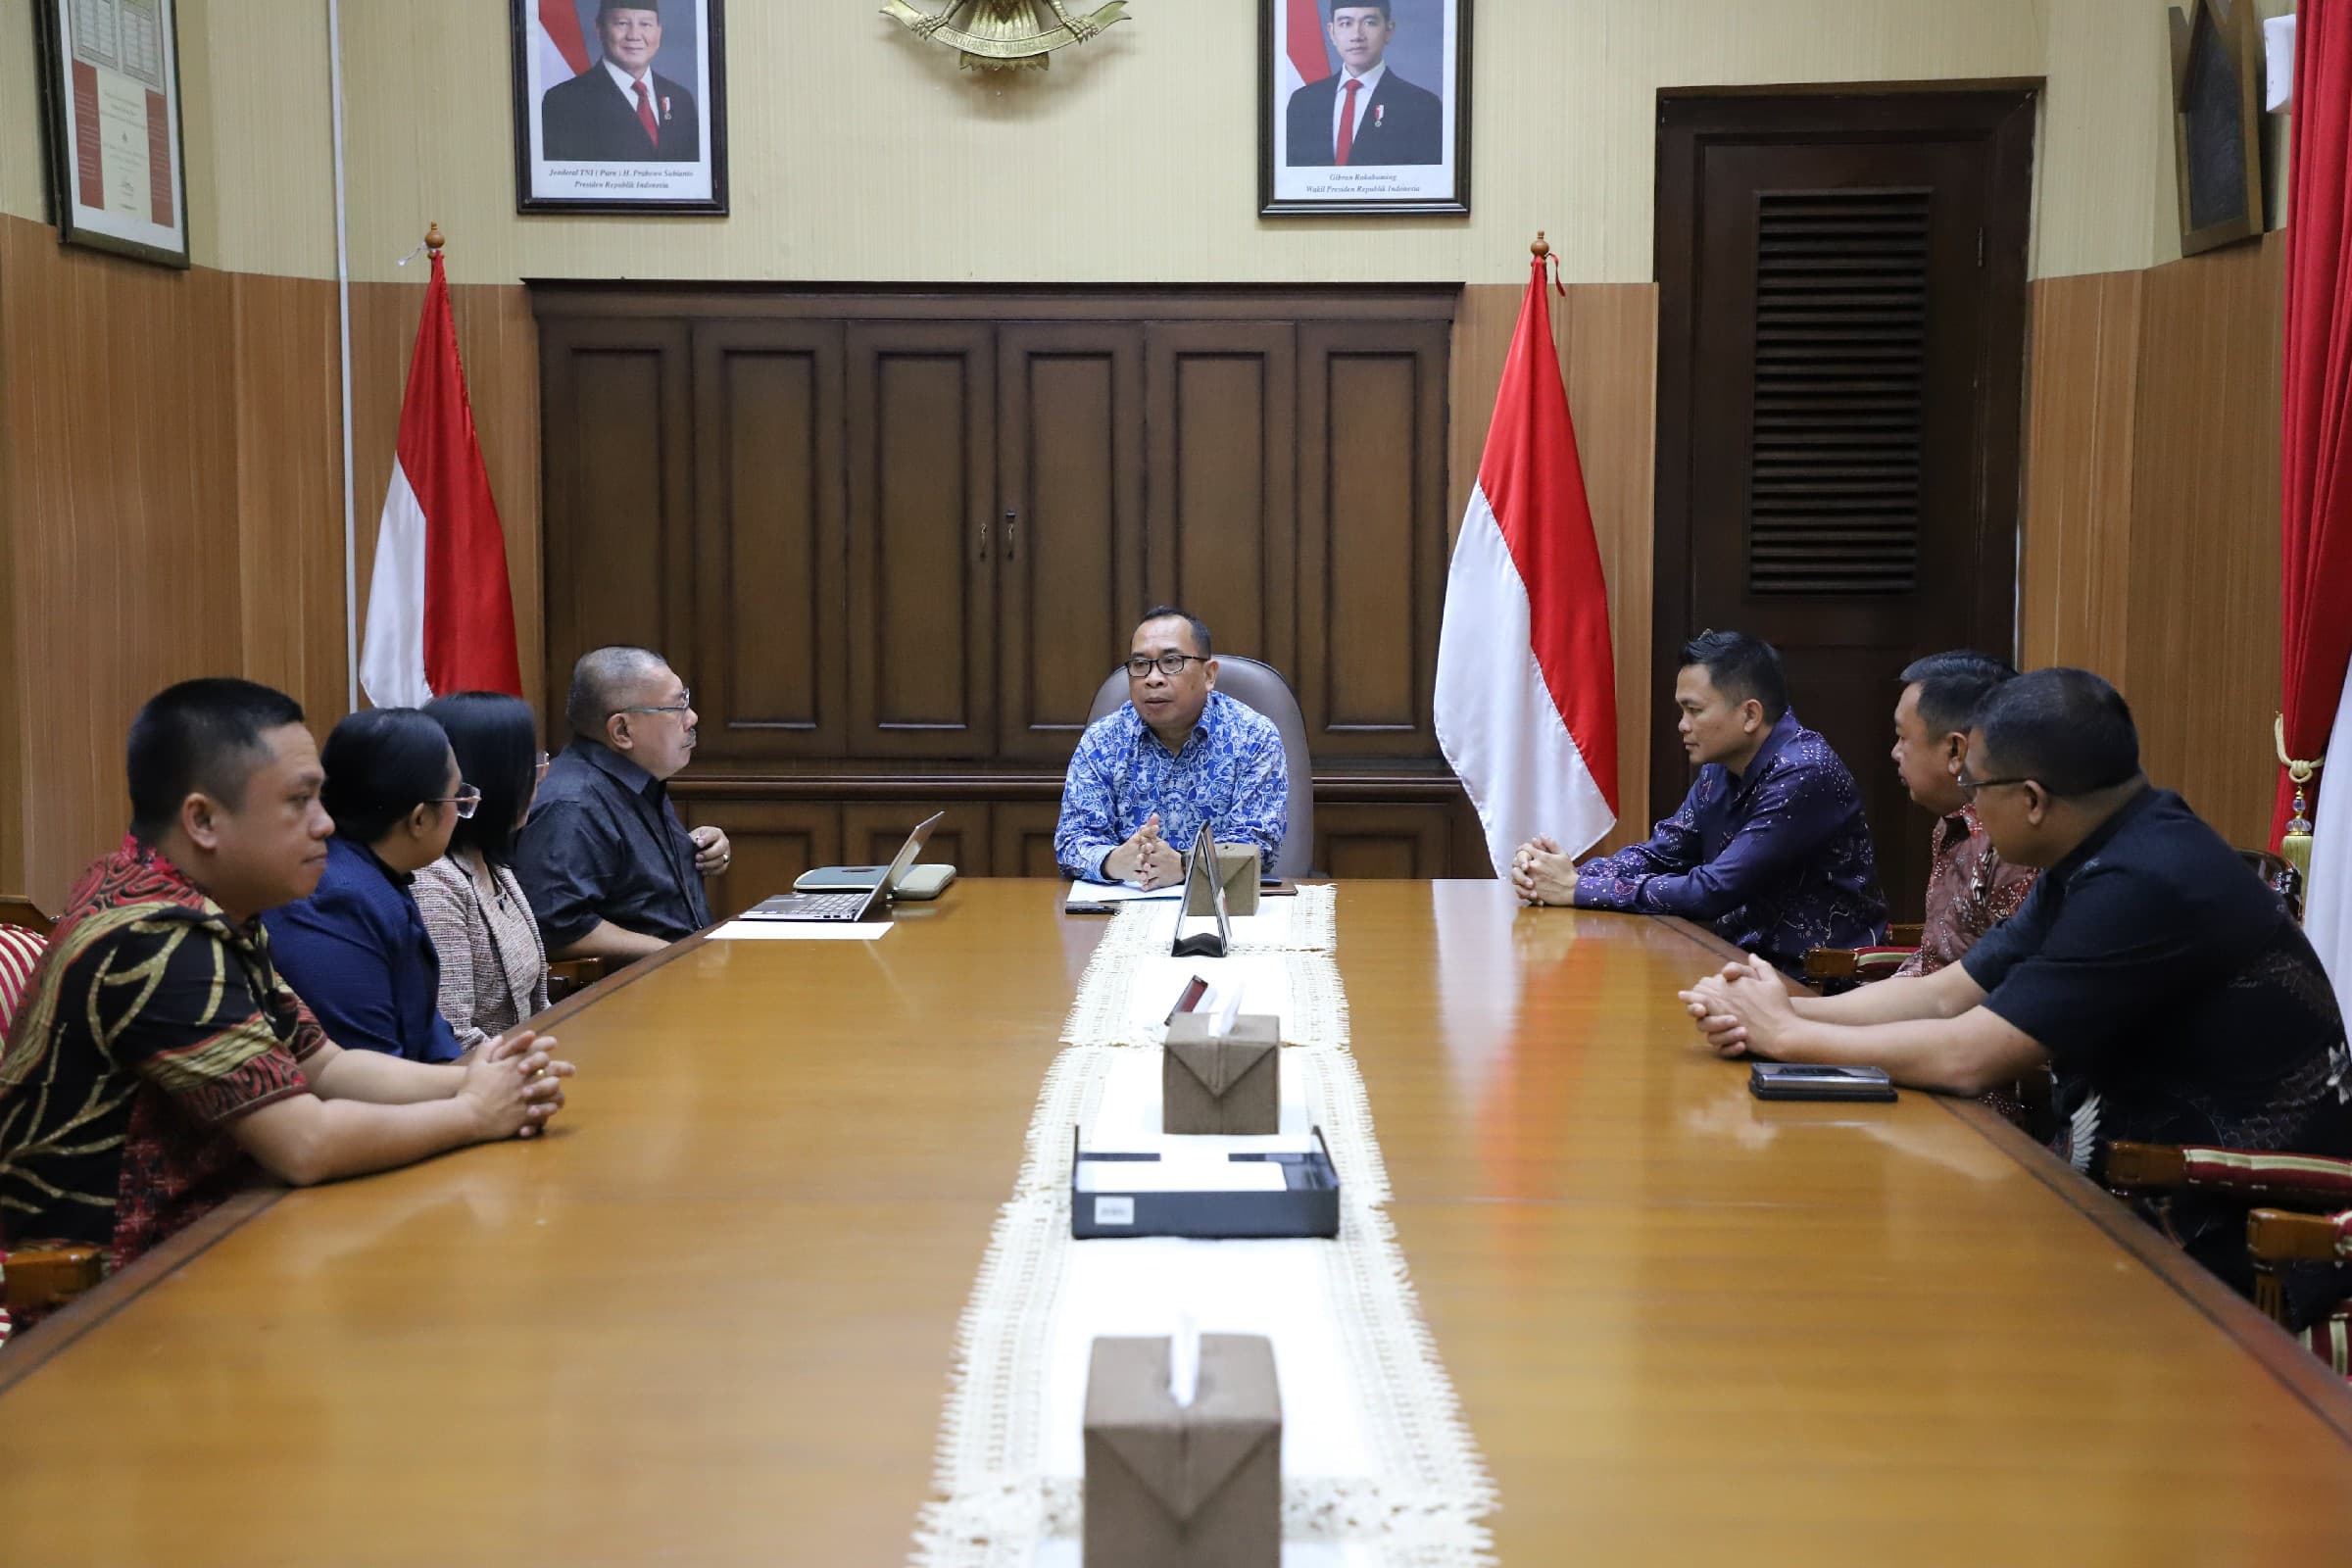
[14,888,2352,1446]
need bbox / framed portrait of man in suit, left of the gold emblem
[508,0,727,214]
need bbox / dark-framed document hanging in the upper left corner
[33,0,188,266]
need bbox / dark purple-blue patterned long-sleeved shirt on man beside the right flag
[1576,712,1886,973]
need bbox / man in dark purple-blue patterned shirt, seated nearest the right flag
[1512,632,1886,973]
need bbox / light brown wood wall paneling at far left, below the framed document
[0,219,245,909]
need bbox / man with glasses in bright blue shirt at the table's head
[1054,604,1289,886]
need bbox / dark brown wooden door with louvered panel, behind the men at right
[1651,89,2033,919]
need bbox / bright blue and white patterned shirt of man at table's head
[1054,691,1292,882]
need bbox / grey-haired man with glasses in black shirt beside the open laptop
[515,649,734,961]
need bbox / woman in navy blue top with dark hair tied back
[261,708,482,1062]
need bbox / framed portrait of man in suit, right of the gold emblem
[1258,0,1470,219]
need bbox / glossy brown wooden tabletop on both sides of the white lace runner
[0,882,2352,1568]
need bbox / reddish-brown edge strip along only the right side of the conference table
[1653,914,2352,1446]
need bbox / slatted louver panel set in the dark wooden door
[1747,190,1929,595]
